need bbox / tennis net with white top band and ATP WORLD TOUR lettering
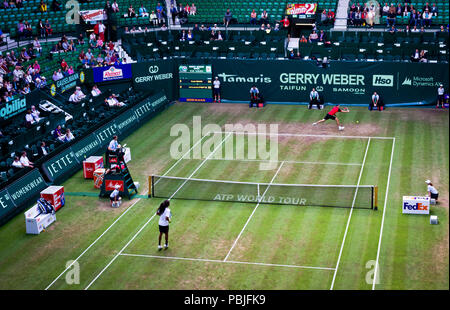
[149,175,378,210]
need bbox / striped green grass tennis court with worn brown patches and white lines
[0,103,449,290]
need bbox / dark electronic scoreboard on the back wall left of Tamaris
[178,65,212,102]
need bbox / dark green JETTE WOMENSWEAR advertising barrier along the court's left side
[0,92,169,225]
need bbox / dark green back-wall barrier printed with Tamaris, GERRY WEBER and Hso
[132,58,449,105]
